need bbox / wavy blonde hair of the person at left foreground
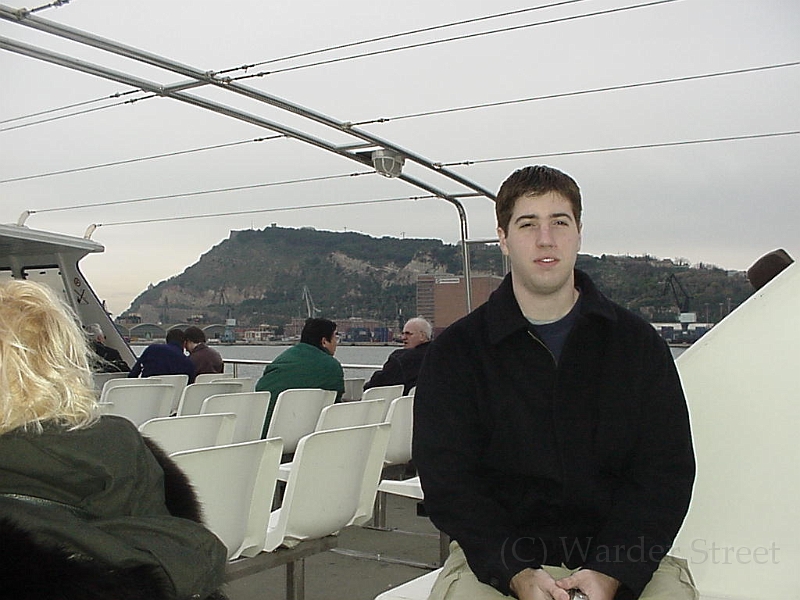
[0,280,98,434]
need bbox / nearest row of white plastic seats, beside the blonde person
[172,423,391,600]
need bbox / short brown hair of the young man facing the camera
[494,165,583,233]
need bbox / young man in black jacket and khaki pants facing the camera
[414,166,696,600]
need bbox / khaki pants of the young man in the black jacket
[428,542,699,600]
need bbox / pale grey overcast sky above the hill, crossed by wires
[0,0,800,314]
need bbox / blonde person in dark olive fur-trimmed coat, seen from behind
[0,280,227,600]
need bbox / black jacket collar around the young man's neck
[486,269,617,344]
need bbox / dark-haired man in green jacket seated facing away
[256,319,344,437]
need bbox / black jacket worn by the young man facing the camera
[413,271,695,598]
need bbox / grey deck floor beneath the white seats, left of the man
[225,496,439,600]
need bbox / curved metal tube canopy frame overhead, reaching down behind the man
[0,4,495,312]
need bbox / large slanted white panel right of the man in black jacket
[671,263,800,600]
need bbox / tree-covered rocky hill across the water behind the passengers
[121,226,752,327]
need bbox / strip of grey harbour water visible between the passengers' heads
[131,345,686,379]
